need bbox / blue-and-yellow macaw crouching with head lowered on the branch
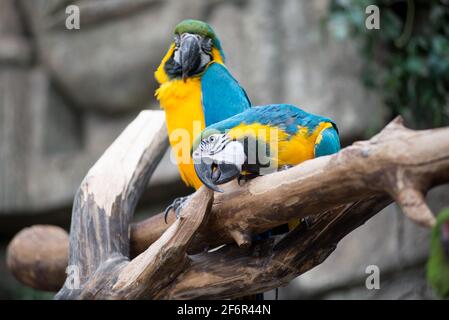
[191,104,340,229]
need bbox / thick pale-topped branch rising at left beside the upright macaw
[53,111,168,299]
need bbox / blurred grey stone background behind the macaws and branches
[0,0,442,299]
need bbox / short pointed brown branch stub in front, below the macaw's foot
[70,188,213,299]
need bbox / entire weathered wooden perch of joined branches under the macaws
[8,115,449,299]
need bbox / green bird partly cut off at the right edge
[427,208,449,299]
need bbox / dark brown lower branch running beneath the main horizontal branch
[156,196,391,299]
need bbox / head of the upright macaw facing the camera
[162,19,224,81]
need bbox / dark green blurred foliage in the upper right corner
[327,0,449,128]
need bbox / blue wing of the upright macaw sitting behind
[201,63,251,127]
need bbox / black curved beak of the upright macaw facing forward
[180,34,201,81]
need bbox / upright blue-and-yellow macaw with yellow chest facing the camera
[155,19,251,217]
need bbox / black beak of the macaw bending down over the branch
[194,158,240,193]
